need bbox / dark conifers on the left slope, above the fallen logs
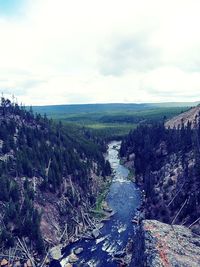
[0,97,111,252]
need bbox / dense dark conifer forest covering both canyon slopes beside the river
[0,97,200,266]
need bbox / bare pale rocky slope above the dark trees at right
[165,106,200,128]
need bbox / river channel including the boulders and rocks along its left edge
[51,141,141,267]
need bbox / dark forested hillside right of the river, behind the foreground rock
[120,116,200,232]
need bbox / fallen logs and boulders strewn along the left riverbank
[0,175,111,267]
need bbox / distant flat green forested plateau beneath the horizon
[33,102,199,139]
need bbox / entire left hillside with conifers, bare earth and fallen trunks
[0,98,110,254]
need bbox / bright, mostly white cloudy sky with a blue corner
[0,0,200,105]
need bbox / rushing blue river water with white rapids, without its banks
[58,141,141,267]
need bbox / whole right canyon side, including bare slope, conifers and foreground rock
[121,107,200,267]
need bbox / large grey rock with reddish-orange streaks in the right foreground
[130,220,200,267]
